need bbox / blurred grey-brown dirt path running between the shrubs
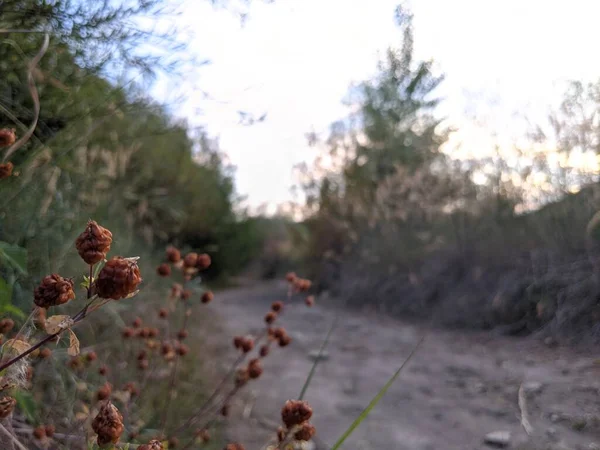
[215,283,600,450]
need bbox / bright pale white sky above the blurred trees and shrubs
[154,0,600,211]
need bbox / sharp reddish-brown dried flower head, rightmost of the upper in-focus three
[96,256,142,300]
